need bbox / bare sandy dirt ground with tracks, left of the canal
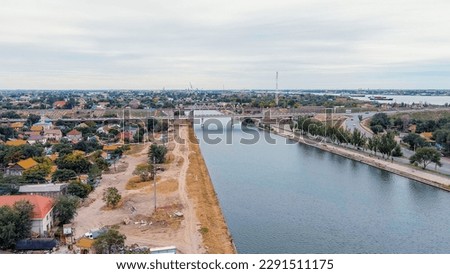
[73,126,234,254]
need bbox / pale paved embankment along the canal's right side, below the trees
[272,128,450,191]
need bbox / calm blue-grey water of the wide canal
[195,111,450,253]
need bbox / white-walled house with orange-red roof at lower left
[0,195,53,236]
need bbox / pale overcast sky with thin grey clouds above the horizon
[0,0,450,89]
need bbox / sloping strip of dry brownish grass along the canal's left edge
[187,126,237,254]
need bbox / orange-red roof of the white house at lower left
[0,195,53,219]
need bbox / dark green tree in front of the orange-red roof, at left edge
[0,201,33,249]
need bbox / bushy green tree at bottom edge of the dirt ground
[93,229,127,254]
